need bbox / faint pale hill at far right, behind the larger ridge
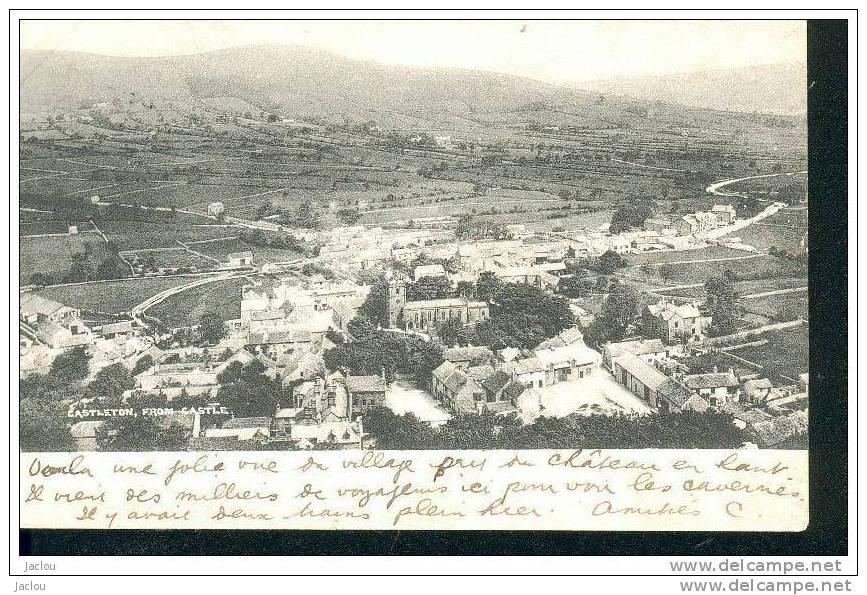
[575,63,807,115]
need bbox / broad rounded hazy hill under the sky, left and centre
[21,46,585,116]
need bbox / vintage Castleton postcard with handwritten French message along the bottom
[13,19,816,532]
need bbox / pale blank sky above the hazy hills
[20,20,806,84]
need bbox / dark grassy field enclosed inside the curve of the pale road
[147,279,249,328]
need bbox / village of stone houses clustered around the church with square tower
[19,199,808,450]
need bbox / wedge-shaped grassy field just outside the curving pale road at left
[37,277,194,314]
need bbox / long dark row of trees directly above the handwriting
[364,407,748,450]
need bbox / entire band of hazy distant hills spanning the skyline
[20,45,806,118]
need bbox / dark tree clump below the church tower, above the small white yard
[324,330,444,384]
